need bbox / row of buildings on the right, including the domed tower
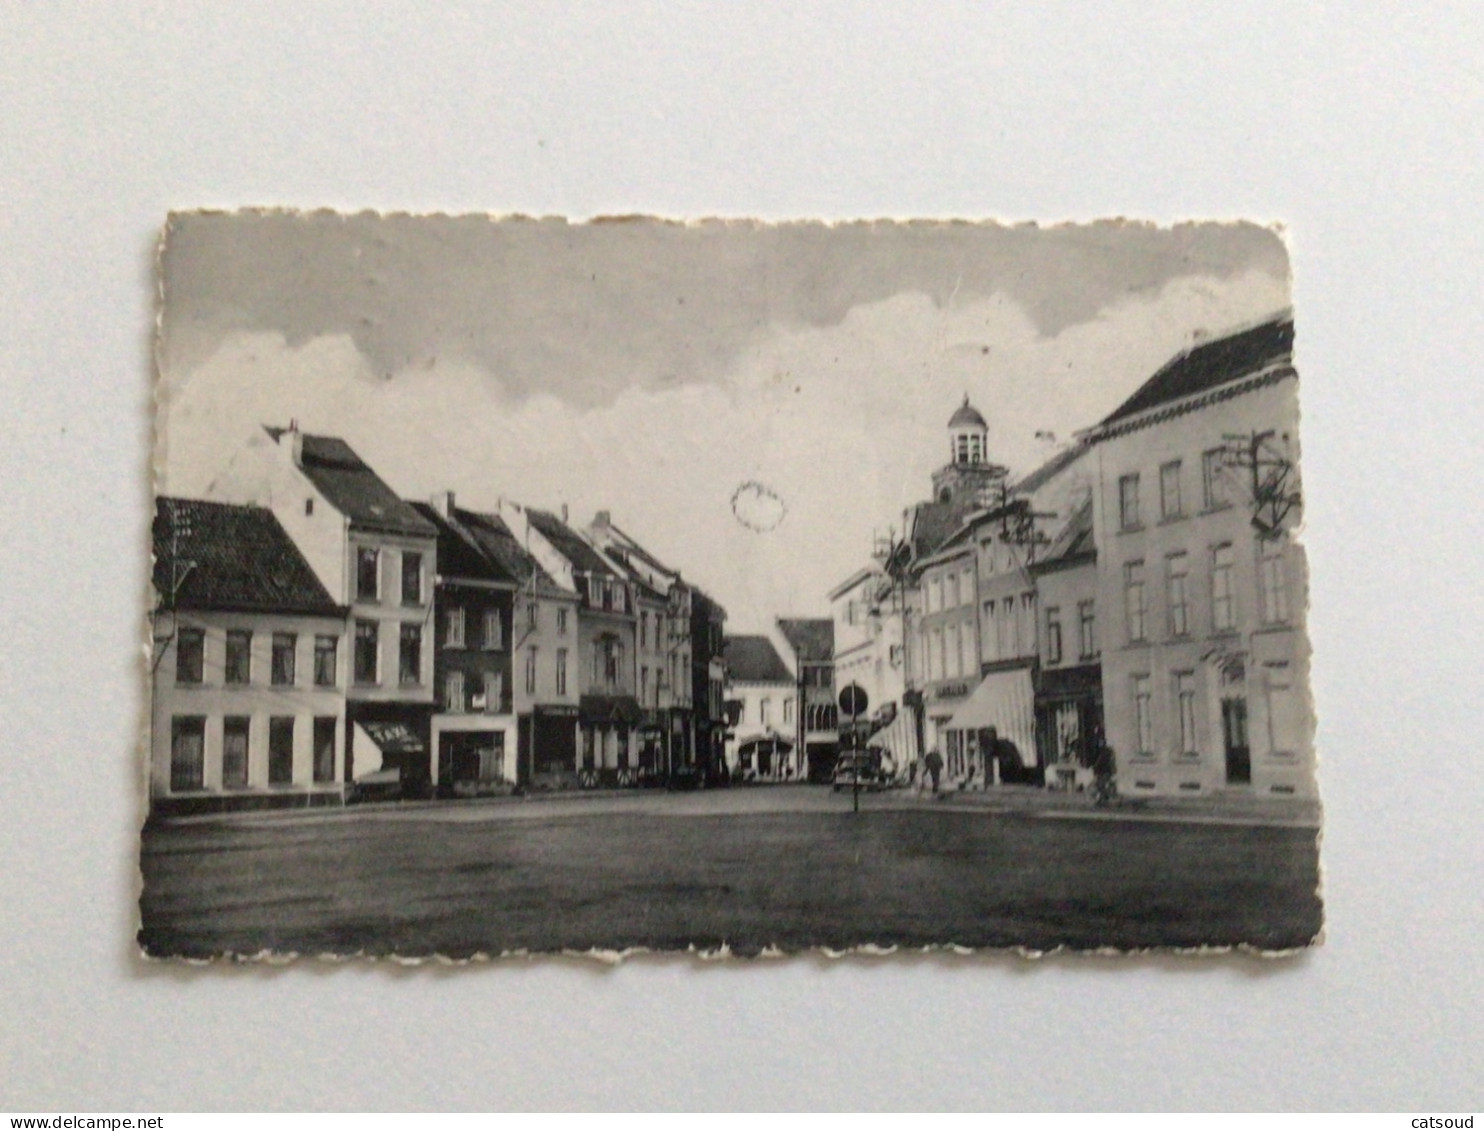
[831,315,1313,794]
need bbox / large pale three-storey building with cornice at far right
[1086,316,1315,797]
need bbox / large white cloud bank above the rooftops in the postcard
[157,272,1288,631]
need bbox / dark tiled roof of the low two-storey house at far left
[154,499,346,616]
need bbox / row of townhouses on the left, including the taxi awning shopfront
[150,424,726,813]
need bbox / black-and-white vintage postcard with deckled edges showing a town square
[138,211,1322,959]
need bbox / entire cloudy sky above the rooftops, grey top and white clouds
[157,214,1290,631]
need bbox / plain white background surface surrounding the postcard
[0,0,1484,1112]
